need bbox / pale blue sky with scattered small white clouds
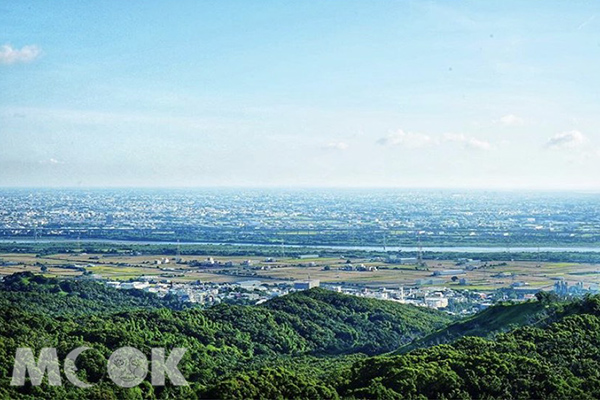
[0,0,600,190]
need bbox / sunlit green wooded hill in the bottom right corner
[337,297,600,399]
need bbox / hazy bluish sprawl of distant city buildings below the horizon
[0,189,600,247]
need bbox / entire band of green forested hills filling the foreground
[0,274,600,399]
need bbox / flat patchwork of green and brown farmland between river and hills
[0,253,600,291]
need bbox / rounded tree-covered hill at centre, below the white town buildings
[264,289,453,354]
